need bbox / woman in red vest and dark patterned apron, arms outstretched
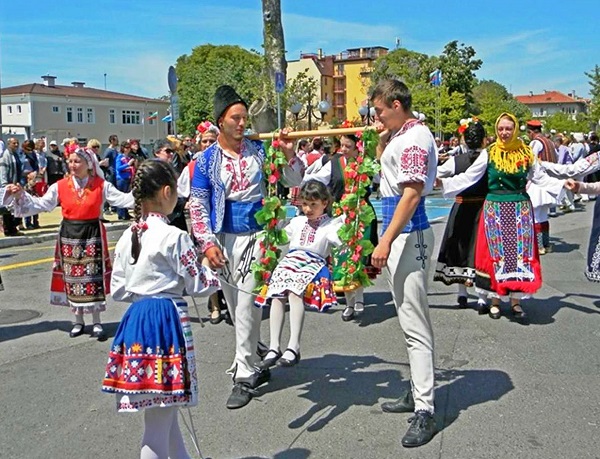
[2,148,133,341]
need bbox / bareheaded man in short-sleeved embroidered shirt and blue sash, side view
[371,80,438,447]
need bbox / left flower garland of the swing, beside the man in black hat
[251,140,288,294]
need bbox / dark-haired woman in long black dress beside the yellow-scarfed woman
[433,118,488,314]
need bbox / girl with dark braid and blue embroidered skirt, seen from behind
[102,160,219,459]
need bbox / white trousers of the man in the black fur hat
[219,233,262,382]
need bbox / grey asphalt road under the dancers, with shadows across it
[0,203,600,459]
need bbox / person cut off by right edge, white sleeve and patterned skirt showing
[543,151,600,282]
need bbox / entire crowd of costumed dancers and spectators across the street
[0,79,600,458]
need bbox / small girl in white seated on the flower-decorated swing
[256,180,344,370]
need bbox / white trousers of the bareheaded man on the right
[386,228,434,414]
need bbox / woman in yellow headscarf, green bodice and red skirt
[445,113,564,320]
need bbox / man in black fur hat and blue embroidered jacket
[190,85,302,409]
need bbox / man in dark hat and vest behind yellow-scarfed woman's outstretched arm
[527,120,557,255]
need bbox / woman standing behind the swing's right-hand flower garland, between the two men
[303,135,380,322]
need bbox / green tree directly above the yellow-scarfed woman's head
[471,80,531,134]
